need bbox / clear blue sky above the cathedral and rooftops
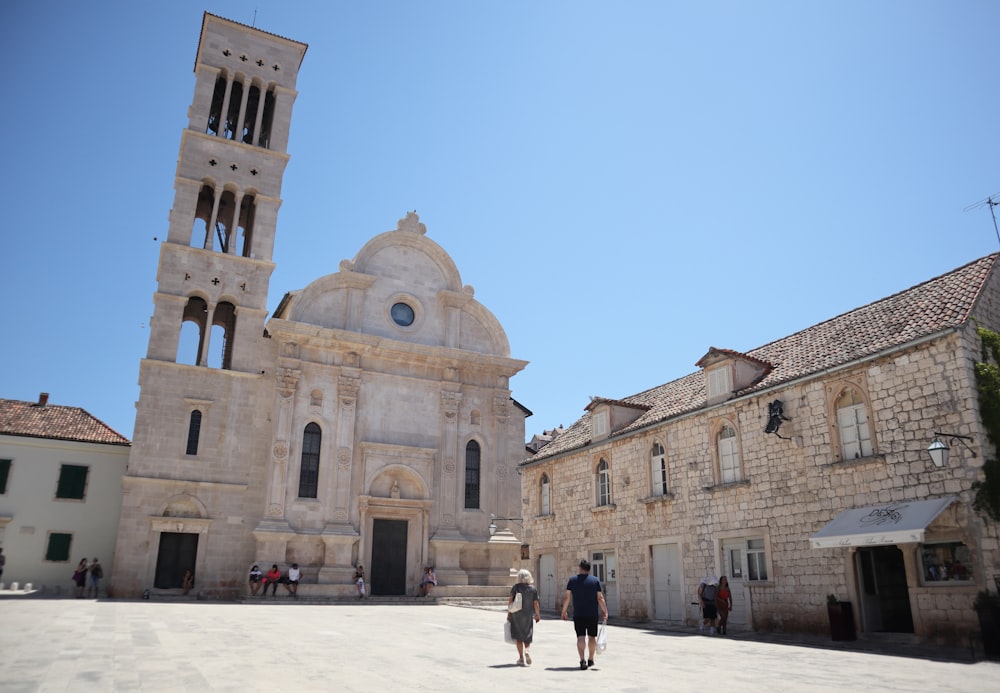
[0,0,1000,438]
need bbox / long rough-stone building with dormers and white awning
[522,255,1000,638]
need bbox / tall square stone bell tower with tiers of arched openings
[111,13,307,596]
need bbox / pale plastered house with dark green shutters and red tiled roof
[0,392,129,594]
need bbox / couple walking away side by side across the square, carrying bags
[507,559,608,669]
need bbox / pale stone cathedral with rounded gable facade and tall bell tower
[110,13,530,598]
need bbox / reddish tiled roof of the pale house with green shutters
[0,399,132,445]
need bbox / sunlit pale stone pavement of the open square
[0,598,1000,693]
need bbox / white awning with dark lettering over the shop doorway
[809,496,956,549]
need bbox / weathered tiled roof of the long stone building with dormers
[530,253,1000,462]
